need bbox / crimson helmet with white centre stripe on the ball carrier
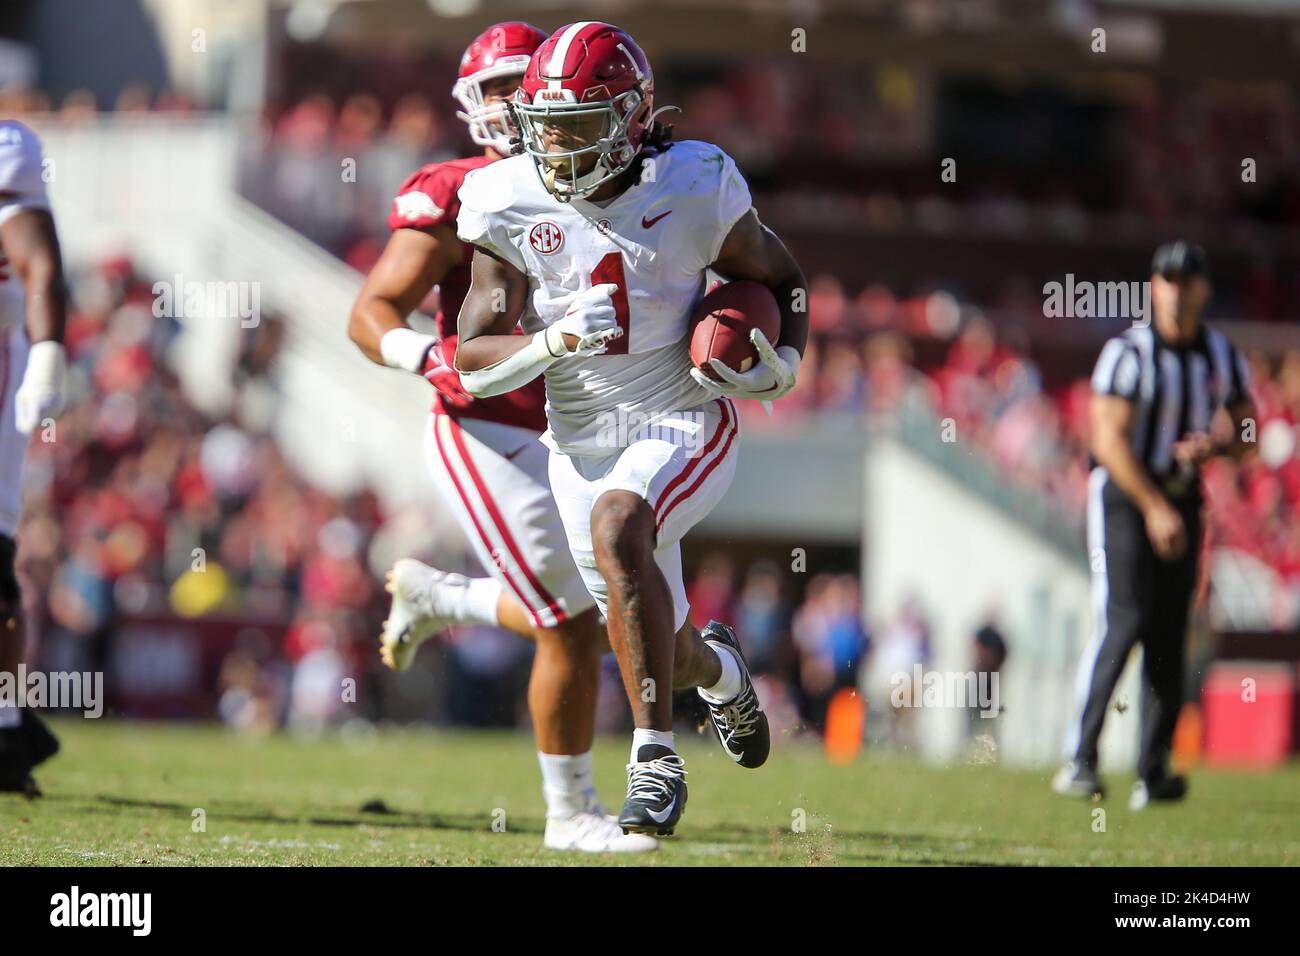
[515,21,654,202]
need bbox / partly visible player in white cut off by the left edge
[0,120,68,796]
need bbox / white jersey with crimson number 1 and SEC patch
[456,140,751,455]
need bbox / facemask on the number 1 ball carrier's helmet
[512,90,645,203]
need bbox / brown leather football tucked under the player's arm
[690,280,781,378]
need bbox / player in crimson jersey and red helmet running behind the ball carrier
[348,22,657,852]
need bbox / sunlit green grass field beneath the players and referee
[0,722,1300,866]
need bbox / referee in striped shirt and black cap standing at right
[1052,241,1255,810]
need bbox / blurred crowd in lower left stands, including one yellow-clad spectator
[18,259,382,726]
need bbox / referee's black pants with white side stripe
[1074,468,1201,780]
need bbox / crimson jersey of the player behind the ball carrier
[389,156,546,432]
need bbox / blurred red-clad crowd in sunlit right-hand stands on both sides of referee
[750,283,1300,627]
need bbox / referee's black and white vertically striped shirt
[1092,324,1251,479]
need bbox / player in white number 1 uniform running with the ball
[454,21,807,834]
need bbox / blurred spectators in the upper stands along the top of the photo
[10,54,1284,320]
